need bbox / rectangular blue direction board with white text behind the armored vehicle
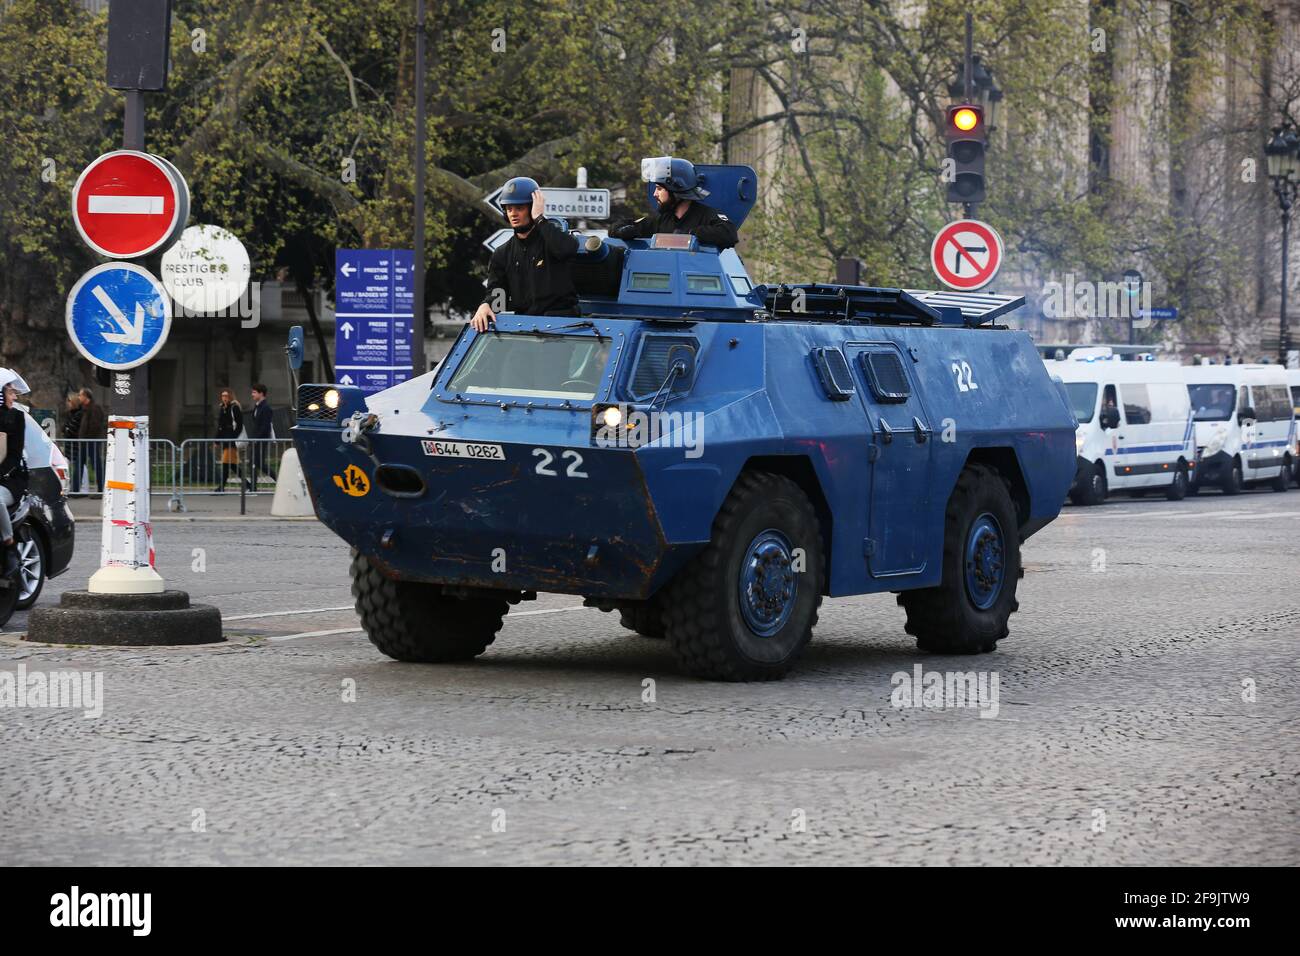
[334,248,415,393]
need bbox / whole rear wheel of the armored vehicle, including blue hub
[898,464,1021,654]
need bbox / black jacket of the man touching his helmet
[484,219,577,315]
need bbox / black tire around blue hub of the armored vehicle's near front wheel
[662,471,826,680]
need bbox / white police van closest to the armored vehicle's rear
[1044,347,1196,505]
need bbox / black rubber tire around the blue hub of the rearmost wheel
[898,464,1021,654]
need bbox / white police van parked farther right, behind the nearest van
[1184,365,1296,494]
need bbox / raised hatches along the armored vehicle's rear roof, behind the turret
[766,282,1024,326]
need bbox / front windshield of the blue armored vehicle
[447,333,610,401]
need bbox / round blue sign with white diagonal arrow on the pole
[66,263,172,372]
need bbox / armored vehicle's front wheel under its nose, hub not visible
[351,551,510,663]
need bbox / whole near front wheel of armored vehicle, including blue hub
[663,472,824,680]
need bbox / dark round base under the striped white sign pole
[27,591,225,646]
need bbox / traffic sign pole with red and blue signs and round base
[27,0,222,645]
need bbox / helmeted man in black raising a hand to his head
[469,176,577,332]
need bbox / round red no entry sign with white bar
[73,150,190,259]
